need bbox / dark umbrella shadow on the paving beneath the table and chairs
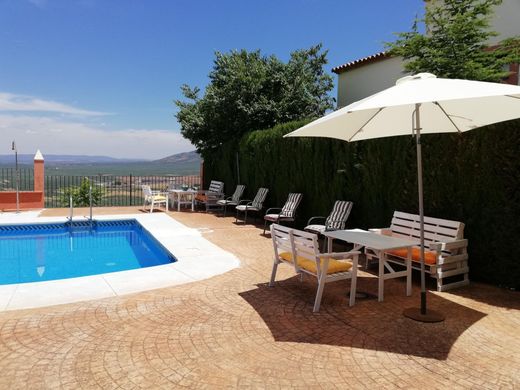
[239,277,486,360]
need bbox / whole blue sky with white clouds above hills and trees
[0,0,423,159]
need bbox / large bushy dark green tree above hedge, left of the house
[175,45,334,155]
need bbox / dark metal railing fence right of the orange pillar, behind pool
[45,175,200,208]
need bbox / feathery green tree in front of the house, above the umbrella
[386,0,520,82]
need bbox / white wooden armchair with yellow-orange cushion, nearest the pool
[269,223,360,312]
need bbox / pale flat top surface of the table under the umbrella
[323,229,419,250]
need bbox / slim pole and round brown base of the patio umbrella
[403,103,444,322]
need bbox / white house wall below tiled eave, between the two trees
[338,57,406,108]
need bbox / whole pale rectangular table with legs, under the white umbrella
[323,229,419,302]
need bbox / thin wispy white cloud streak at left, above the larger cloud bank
[0,92,110,116]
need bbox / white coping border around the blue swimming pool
[0,212,240,311]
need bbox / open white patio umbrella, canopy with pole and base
[285,73,520,320]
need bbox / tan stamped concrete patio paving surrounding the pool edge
[0,208,520,389]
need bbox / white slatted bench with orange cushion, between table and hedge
[365,211,469,291]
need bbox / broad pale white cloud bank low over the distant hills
[0,114,194,159]
